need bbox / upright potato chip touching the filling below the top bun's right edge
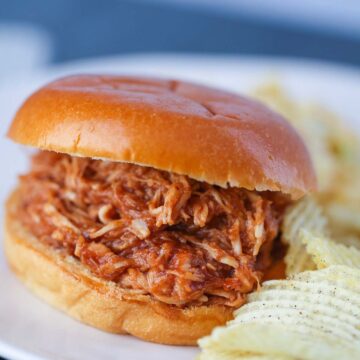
[282,197,327,275]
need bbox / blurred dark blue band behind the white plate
[0,0,360,65]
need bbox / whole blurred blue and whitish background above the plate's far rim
[0,0,360,80]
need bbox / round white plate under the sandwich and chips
[0,55,360,360]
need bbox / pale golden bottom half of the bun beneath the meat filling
[5,192,234,345]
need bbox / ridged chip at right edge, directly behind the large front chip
[301,230,360,269]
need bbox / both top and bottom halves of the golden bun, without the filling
[5,75,316,345]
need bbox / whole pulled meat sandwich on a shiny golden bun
[5,75,315,345]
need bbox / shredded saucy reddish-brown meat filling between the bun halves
[18,151,288,307]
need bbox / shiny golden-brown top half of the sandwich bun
[8,75,316,199]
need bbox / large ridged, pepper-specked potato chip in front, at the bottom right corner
[199,266,360,360]
